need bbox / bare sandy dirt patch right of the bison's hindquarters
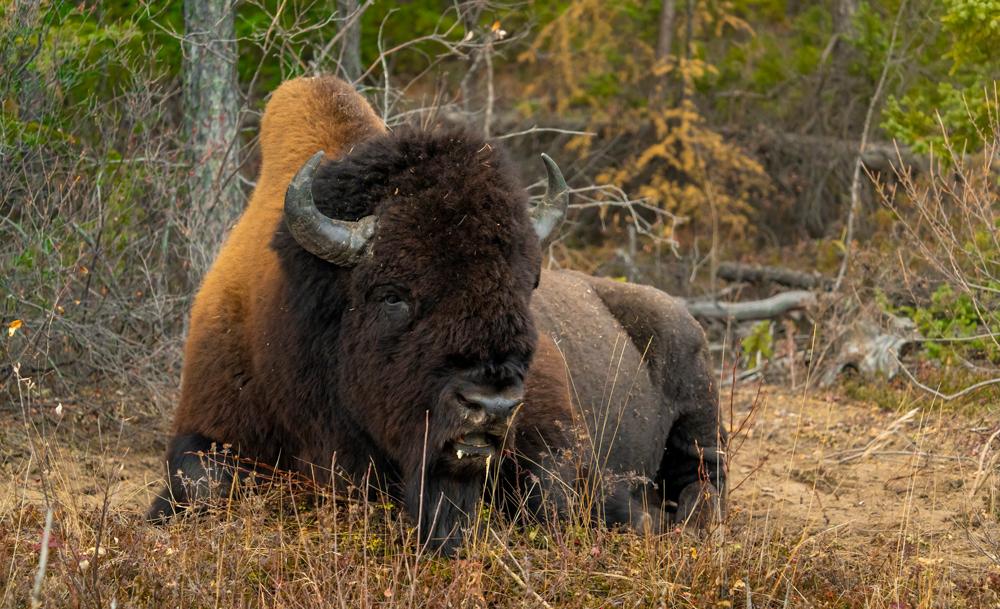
[730,387,998,570]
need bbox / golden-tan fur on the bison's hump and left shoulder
[175,76,386,434]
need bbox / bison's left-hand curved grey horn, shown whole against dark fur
[285,150,377,266]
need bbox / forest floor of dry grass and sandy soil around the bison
[0,386,1000,609]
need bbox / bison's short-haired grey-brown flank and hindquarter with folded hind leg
[529,271,725,521]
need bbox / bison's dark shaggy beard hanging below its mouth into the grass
[406,463,486,555]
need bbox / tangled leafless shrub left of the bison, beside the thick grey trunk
[0,8,188,408]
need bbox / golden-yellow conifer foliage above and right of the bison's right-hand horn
[519,0,770,238]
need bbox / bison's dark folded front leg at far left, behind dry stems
[146,434,243,523]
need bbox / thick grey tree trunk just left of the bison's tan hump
[183,0,240,277]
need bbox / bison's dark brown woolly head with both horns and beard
[275,131,568,552]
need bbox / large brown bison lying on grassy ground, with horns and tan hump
[148,76,725,550]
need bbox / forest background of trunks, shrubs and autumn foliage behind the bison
[0,0,1000,396]
